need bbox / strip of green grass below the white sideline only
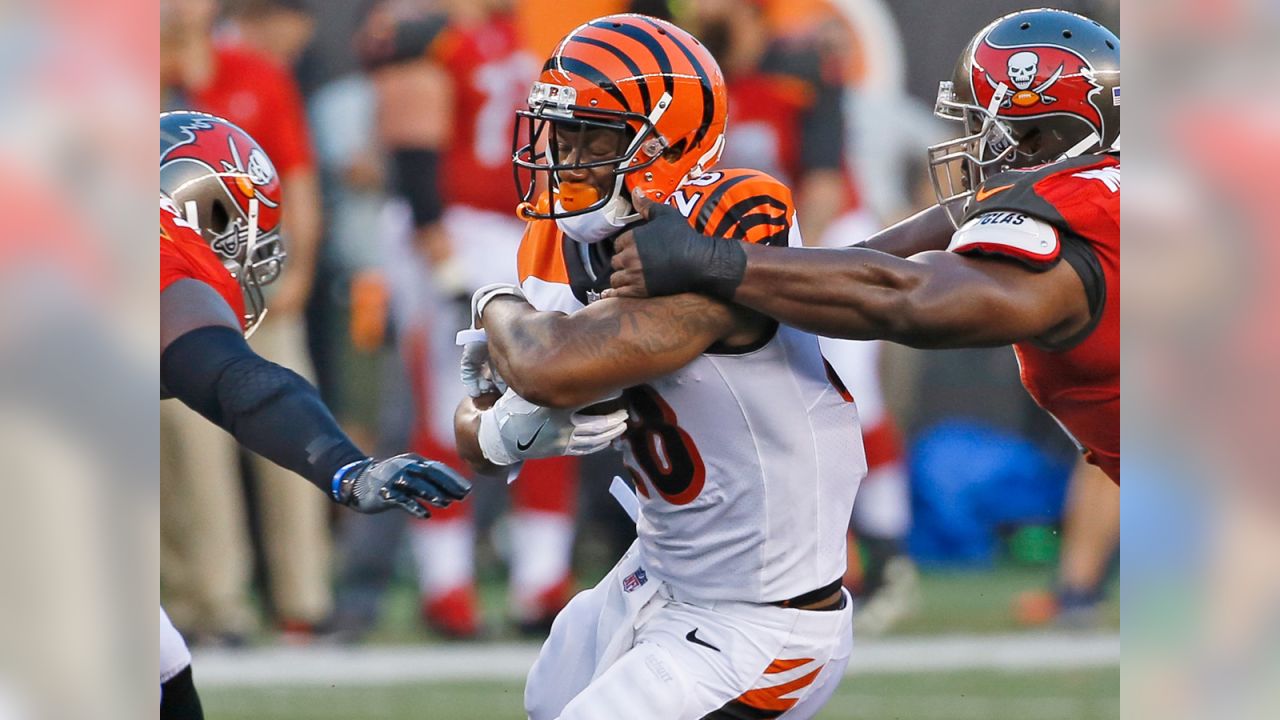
[201,669,1120,720]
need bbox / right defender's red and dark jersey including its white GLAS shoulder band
[950,155,1120,483]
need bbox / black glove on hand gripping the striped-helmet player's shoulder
[631,201,746,300]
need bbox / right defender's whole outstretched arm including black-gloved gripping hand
[609,197,1089,347]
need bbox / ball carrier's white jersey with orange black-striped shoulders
[518,170,867,602]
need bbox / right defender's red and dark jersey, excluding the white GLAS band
[966,155,1120,483]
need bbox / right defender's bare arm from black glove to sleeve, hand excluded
[733,246,1083,347]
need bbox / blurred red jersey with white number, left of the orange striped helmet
[429,14,538,213]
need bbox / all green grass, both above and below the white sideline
[196,565,1120,720]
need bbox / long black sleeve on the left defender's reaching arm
[160,325,365,495]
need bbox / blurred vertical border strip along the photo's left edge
[0,1,159,720]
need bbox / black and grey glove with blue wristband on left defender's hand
[333,452,471,518]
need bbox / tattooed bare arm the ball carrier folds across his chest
[484,289,737,407]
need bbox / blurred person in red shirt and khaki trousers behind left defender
[160,0,333,643]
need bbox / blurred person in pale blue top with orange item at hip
[261,0,409,641]
